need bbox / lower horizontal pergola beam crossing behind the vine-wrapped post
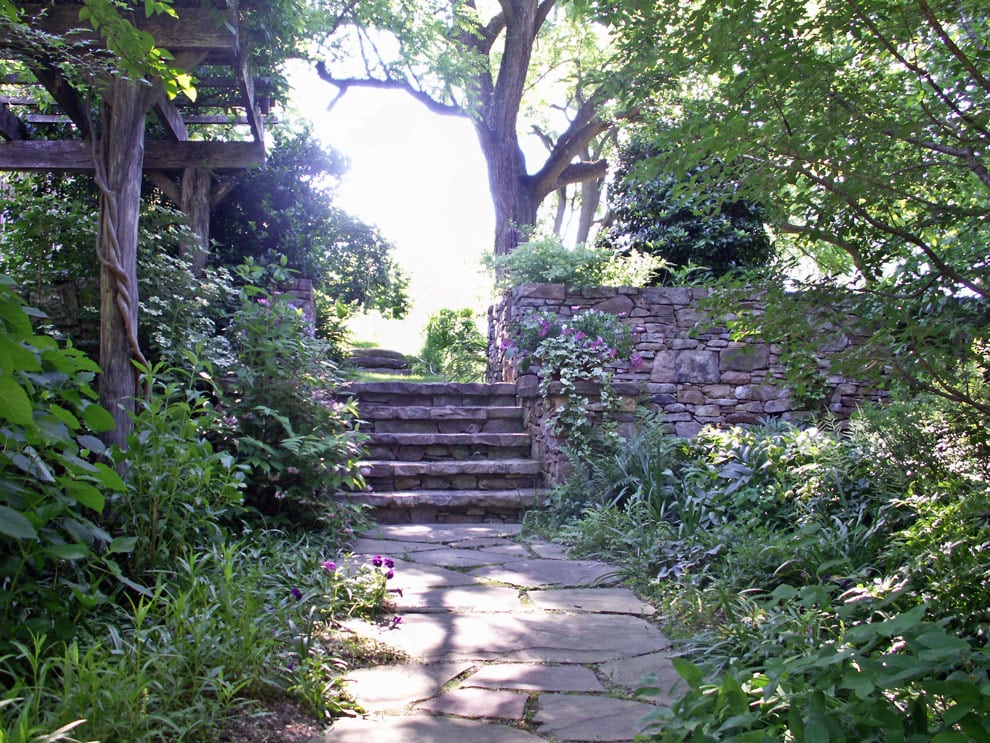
[0,140,265,171]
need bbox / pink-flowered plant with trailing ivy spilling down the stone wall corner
[506,307,633,457]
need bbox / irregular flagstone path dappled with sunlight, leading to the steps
[311,524,678,743]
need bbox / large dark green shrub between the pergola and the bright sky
[210,130,409,318]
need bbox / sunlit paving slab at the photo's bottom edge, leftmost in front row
[320,715,543,743]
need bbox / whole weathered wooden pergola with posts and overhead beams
[0,0,265,445]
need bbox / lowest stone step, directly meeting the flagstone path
[340,488,545,524]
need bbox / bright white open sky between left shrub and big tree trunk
[290,63,504,354]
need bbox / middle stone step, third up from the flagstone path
[365,433,531,461]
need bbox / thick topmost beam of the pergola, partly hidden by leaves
[23,4,234,55]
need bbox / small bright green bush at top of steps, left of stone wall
[419,308,488,382]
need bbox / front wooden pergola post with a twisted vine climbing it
[95,78,147,446]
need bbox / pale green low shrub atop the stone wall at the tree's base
[489,237,662,287]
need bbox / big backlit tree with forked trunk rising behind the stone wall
[318,0,610,253]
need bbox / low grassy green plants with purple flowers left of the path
[0,531,387,741]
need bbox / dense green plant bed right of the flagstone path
[530,398,990,741]
